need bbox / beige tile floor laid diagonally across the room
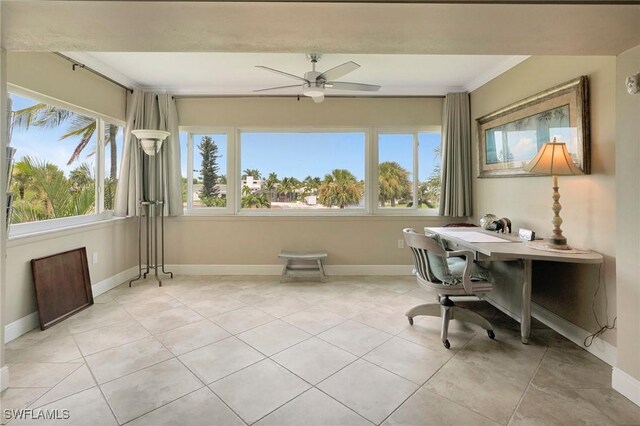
[1,277,640,426]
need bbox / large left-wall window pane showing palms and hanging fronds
[10,94,96,224]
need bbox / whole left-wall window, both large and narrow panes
[9,92,122,230]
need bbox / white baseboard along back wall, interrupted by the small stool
[166,265,413,275]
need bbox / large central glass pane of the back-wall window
[239,132,365,210]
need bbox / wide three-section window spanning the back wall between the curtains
[180,128,440,215]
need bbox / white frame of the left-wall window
[7,83,125,239]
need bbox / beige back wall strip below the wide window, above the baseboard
[167,217,445,266]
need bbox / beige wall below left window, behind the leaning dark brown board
[4,219,137,325]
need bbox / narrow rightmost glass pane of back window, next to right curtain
[418,132,441,209]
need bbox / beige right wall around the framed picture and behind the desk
[471,56,616,345]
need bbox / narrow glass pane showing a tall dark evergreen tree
[192,134,227,208]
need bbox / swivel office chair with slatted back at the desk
[402,228,495,349]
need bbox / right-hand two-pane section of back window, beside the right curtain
[377,132,440,211]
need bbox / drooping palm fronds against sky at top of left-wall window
[12,103,118,181]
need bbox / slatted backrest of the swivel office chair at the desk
[402,228,450,284]
